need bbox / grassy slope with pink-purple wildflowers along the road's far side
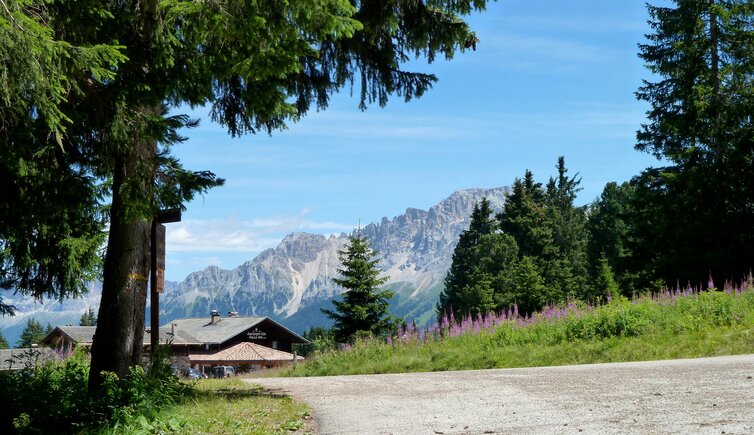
[281,288,754,376]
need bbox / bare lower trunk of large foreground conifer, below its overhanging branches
[89,140,155,393]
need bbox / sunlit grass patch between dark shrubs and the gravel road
[133,379,313,434]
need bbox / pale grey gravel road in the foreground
[248,355,754,434]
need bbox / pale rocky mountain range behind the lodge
[0,187,508,345]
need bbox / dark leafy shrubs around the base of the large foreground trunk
[0,352,190,433]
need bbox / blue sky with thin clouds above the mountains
[166,0,658,281]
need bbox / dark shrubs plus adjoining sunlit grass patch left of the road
[0,352,308,434]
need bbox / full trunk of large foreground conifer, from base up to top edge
[88,0,161,394]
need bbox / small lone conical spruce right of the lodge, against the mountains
[322,234,396,343]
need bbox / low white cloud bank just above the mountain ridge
[166,209,353,253]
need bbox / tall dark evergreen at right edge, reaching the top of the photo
[633,0,754,283]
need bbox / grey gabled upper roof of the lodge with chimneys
[160,316,309,344]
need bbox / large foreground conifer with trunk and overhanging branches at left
[0,0,486,392]
